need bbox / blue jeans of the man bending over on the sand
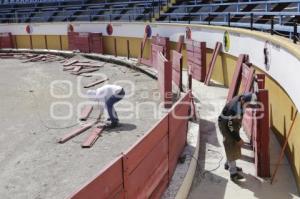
[105,89,125,124]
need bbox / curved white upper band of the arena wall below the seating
[0,22,300,110]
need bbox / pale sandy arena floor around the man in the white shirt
[0,55,159,199]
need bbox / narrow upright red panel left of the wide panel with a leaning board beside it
[172,50,182,91]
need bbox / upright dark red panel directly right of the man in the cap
[255,90,270,177]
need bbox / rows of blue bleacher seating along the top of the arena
[0,0,300,40]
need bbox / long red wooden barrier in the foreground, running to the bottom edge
[69,92,191,199]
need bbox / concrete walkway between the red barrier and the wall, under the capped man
[184,75,299,199]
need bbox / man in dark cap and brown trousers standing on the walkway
[218,93,256,181]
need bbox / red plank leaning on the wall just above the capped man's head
[227,54,247,102]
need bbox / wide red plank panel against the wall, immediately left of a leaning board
[186,40,206,82]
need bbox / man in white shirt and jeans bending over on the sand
[87,84,125,128]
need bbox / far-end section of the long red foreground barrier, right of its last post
[169,92,191,179]
